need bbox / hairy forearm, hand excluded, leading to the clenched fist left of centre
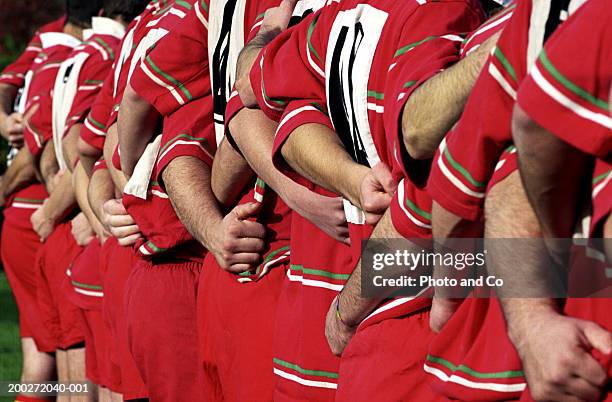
[162,156,223,251]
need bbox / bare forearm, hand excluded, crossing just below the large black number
[281,124,369,207]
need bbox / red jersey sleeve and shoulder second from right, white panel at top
[428,1,588,220]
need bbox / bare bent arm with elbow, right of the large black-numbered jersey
[402,34,499,159]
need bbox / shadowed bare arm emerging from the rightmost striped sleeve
[512,106,590,238]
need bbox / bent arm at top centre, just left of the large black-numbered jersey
[236,0,297,108]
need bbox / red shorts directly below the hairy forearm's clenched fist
[198,253,287,402]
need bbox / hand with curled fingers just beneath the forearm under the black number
[285,186,350,244]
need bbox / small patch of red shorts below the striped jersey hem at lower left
[79,309,110,388]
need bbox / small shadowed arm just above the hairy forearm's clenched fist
[211,139,253,207]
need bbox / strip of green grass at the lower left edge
[0,271,21,402]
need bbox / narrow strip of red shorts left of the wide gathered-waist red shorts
[100,237,148,400]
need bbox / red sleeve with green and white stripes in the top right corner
[518,0,612,158]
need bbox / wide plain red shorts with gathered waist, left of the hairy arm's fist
[125,258,207,402]
